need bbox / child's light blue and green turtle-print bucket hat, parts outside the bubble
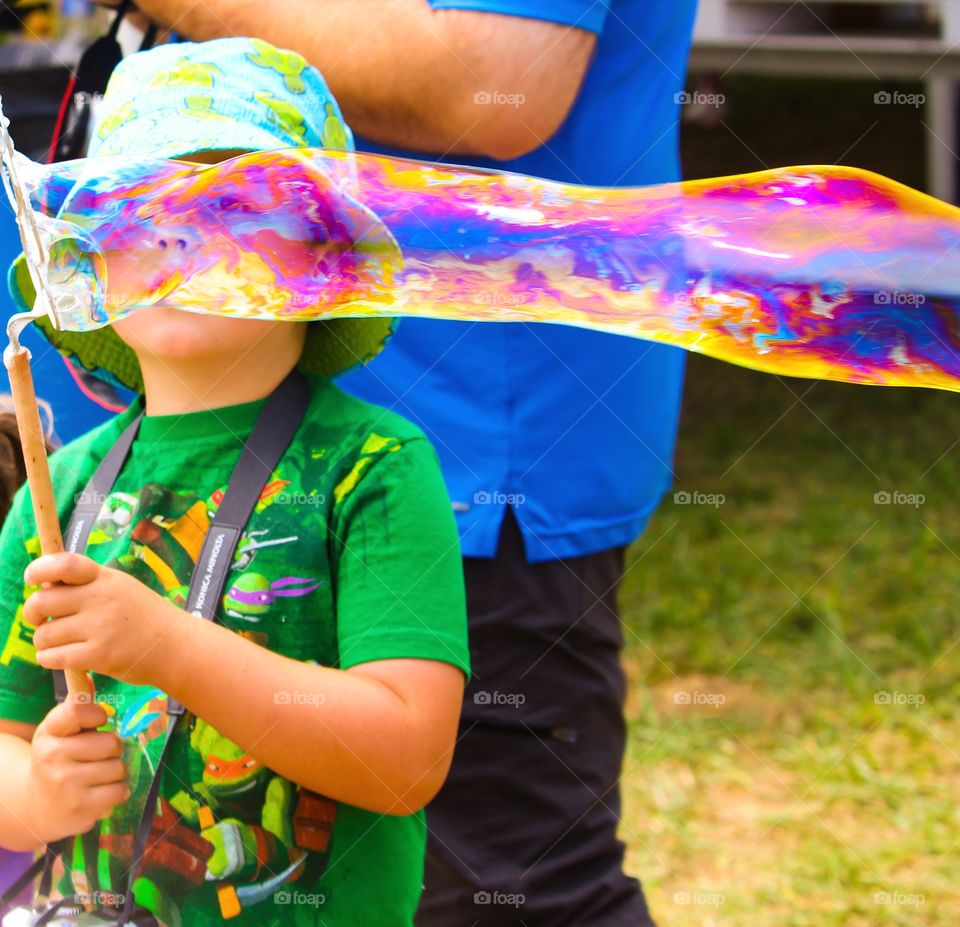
[8,38,397,392]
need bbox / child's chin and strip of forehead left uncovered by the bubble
[113,143,307,363]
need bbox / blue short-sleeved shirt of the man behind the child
[340,0,696,561]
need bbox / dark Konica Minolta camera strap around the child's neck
[27,370,310,927]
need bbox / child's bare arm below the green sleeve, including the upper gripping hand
[24,554,464,814]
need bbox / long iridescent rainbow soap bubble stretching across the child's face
[13,149,960,390]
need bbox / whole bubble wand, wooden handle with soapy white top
[0,98,90,696]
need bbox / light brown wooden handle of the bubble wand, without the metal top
[5,346,90,696]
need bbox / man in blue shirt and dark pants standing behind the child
[90,0,695,927]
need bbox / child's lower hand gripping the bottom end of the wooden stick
[29,698,130,843]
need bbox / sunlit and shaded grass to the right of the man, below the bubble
[622,357,960,927]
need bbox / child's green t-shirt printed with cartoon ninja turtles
[0,378,469,927]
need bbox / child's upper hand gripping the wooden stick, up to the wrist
[23,553,185,688]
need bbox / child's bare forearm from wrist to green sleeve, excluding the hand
[163,636,464,814]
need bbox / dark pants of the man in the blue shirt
[416,512,652,927]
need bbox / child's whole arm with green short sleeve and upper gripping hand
[24,438,468,814]
